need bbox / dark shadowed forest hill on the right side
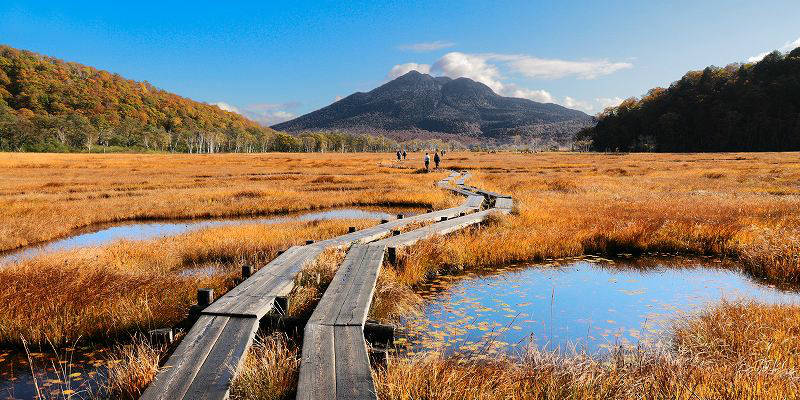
[576,48,800,152]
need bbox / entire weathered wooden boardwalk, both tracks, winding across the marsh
[142,172,511,399]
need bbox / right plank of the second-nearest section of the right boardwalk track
[336,244,385,327]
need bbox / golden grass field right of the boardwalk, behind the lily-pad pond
[392,153,800,284]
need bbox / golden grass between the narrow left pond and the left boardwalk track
[0,220,373,345]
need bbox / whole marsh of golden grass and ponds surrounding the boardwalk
[0,152,800,399]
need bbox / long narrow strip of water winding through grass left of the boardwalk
[0,208,406,266]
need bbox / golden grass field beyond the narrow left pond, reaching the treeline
[0,153,460,251]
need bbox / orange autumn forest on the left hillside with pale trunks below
[0,46,432,153]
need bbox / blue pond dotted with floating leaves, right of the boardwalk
[405,258,800,355]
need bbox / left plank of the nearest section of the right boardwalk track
[296,324,336,400]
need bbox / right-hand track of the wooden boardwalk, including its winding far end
[297,173,511,400]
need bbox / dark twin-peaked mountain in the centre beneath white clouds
[273,71,592,142]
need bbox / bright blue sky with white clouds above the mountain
[0,0,800,123]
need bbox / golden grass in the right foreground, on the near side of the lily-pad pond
[374,304,800,400]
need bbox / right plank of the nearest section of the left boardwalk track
[183,318,258,400]
